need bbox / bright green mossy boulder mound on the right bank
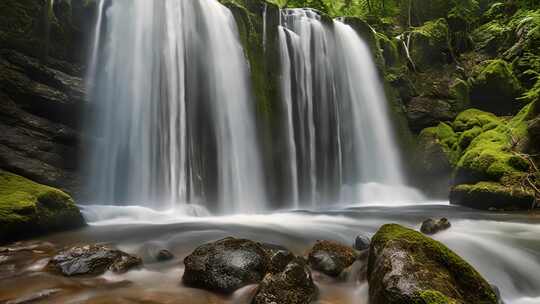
[417,103,540,209]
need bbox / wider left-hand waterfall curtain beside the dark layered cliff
[88,0,265,213]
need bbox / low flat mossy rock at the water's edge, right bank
[450,182,535,210]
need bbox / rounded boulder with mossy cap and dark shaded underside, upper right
[470,59,523,115]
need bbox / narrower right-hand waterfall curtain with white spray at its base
[279,9,421,209]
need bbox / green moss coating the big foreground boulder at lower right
[368,224,497,304]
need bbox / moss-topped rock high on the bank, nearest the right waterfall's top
[410,18,452,70]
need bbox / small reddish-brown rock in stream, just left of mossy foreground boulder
[308,241,357,277]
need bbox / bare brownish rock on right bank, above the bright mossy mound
[407,96,456,132]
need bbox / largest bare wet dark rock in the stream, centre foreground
[182,237,270,293]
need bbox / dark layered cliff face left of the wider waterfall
[0,0,94,192]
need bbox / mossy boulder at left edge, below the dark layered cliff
[0,170,84,242]
